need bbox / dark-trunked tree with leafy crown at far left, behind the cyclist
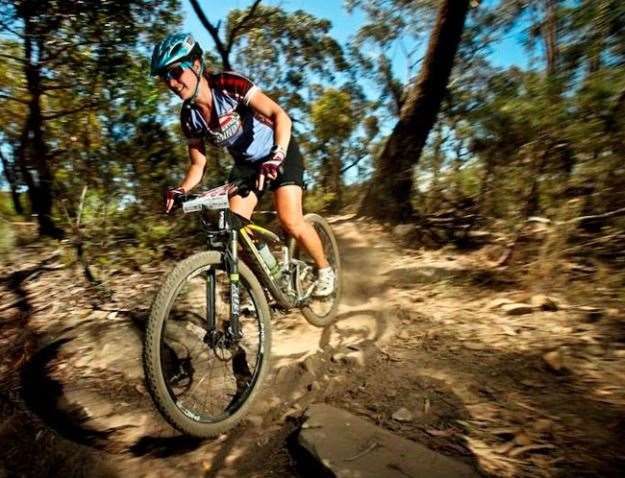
[0,0,178,237]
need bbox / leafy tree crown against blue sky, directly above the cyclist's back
[192,0,349,124]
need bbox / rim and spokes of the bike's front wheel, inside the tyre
[160,266,266,423]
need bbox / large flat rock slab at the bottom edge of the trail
[298,404,479,478]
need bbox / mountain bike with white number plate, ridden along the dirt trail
[143,184,341,437]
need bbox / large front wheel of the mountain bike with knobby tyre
[143,251,271,438]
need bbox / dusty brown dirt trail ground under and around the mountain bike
[0,216,625,477]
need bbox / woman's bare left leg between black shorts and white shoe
[273,185,329,269]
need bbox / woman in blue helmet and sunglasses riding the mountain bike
[151,33,335,297]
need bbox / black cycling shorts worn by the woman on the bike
[228,137,304,197]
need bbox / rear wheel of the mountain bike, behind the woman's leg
[289,214,343,327]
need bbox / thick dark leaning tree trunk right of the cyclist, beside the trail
[359,0,469,222]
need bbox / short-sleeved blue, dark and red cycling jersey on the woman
[180,72,274,162]
